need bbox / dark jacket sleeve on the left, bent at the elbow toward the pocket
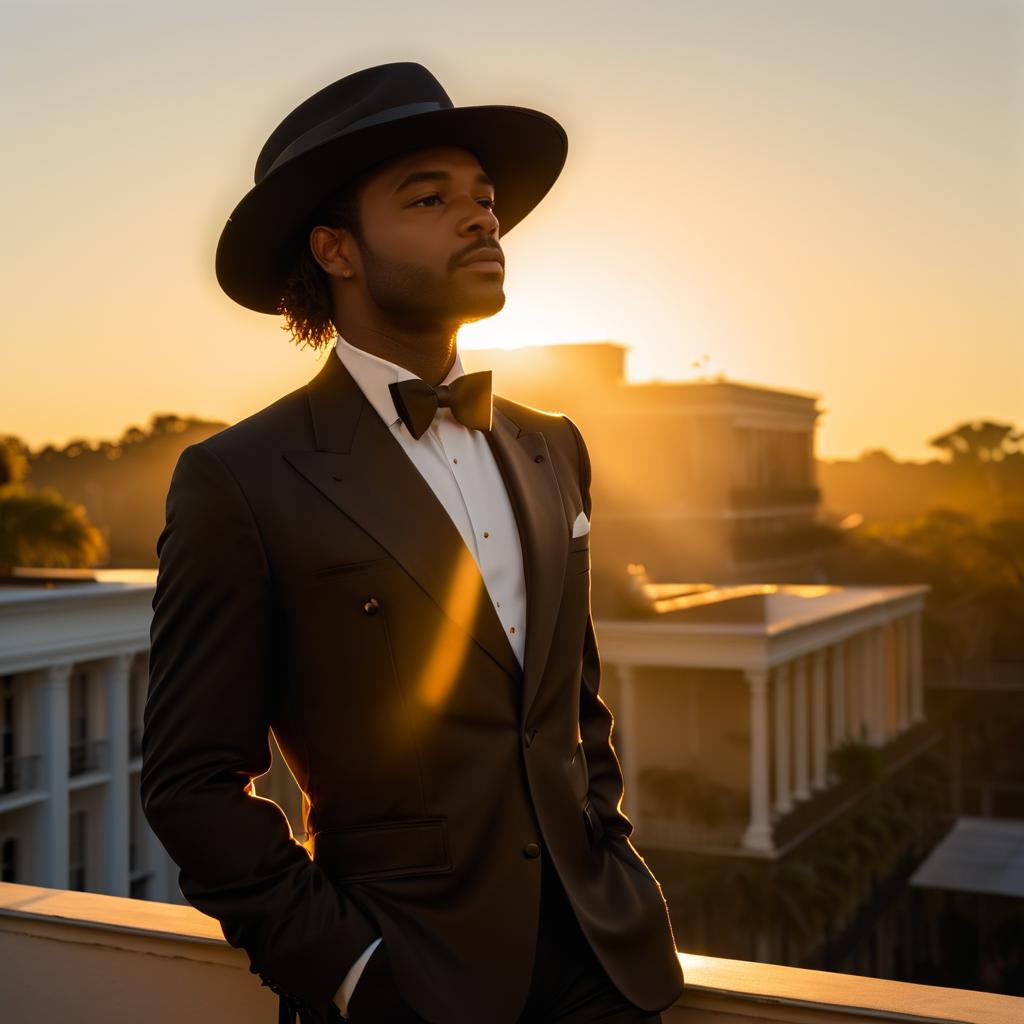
[140,442,380,1021]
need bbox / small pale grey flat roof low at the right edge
[910,817,1024,898]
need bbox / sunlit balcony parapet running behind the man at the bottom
[0,883,1024,1024]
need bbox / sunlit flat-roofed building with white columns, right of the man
[595,577,938,857]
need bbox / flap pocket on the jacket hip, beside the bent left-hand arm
[313,817,452,882]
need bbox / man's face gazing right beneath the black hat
[353,146,505,327]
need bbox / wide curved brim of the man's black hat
[215,105,568,313]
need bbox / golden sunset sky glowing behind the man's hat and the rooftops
[0,0,1024,459]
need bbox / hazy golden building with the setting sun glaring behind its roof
[462,342,822,582]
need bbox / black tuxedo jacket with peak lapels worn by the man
[140,352,683,1024]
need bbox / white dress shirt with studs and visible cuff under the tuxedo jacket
[334,335,526,1018]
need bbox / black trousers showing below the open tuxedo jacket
[348,844,662,1024]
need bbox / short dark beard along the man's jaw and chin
[359,235,505,329]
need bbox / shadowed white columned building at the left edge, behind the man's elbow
[0,569,184,903]
